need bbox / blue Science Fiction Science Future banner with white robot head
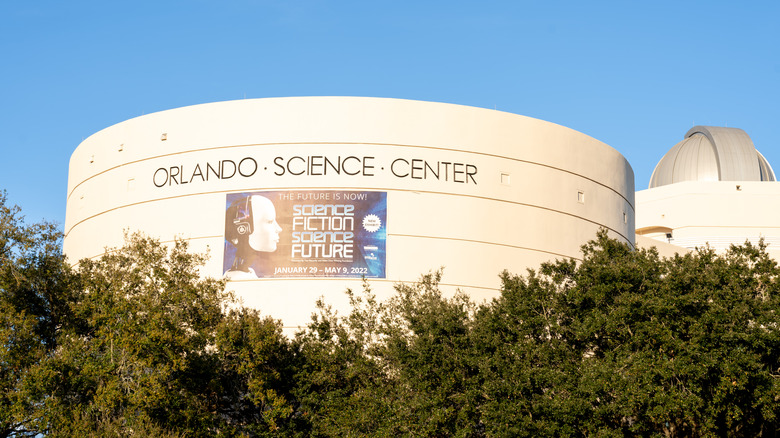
[223,190,387,279]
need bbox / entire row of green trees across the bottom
[0,189,780,437]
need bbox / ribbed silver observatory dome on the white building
[649,126,775,189]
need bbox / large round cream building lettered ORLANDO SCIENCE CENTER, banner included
[63,97,635,328]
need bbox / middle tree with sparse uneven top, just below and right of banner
[294,272,483,436]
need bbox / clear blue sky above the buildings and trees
[0,0,780,226]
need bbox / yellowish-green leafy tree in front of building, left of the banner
[35,236,227,436]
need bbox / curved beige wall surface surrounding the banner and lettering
[64,97,634,327]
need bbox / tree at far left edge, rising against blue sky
[0,192,76,437]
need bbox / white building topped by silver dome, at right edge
[636,126,780,260]
